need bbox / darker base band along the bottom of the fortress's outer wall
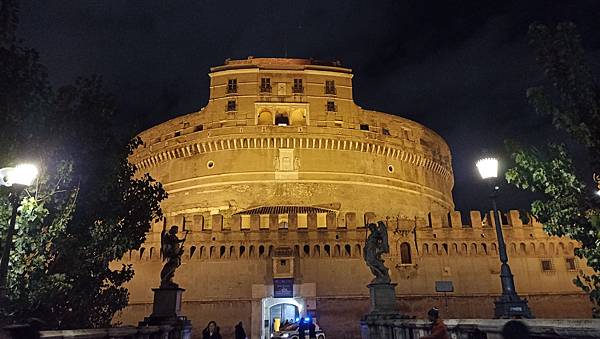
[115,294,592,339]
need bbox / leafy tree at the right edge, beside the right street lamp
[506,23,600,313]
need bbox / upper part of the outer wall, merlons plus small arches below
[125,206,579,269]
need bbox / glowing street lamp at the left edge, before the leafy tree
[0,164,38,304]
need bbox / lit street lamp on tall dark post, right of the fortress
[476,158,533,318]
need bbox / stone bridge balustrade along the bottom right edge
[361,317,600,339]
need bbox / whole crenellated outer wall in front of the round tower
[121,211,591,338]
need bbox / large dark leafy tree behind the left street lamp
[0,0,166,328]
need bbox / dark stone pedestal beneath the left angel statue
[139,287,192,339]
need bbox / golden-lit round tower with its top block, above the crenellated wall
[132,58,454,223]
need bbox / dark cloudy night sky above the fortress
[14,0,600,210]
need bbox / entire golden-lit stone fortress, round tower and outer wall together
[120,57,591,338]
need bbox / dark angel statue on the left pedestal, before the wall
[160,226,189,288]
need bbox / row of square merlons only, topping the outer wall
[153,206,542,232]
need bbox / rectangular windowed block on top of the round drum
[209,57,353,126]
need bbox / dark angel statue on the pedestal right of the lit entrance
[363,221,391,284]
